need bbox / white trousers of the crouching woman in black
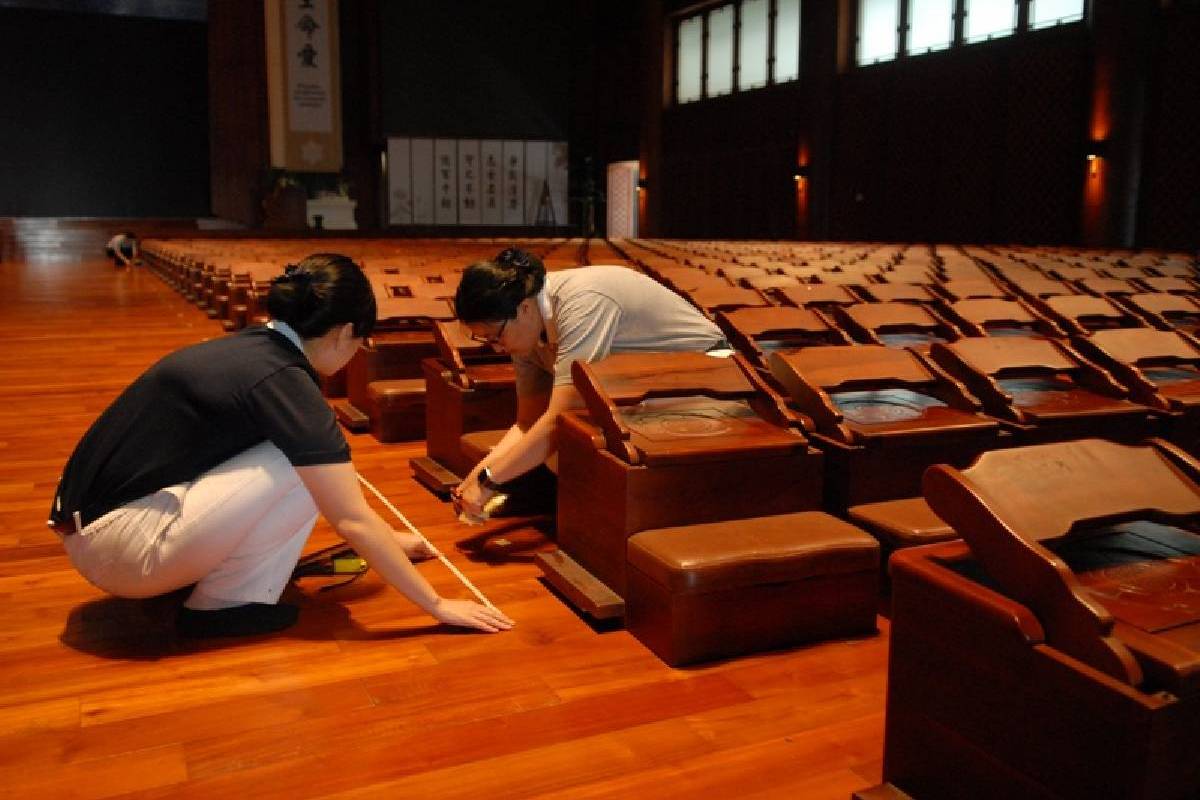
[62,443,317,609]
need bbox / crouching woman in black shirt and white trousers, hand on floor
[50,254,512,636]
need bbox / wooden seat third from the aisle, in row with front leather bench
[929,337,1159,443]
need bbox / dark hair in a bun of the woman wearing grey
[454,247,546,323]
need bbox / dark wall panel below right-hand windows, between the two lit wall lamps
[830,26,1087,242]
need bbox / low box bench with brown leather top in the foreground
[625,511,880,666]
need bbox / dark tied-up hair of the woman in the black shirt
[266,253,376,339]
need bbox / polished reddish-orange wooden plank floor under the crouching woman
[0,221,887,800]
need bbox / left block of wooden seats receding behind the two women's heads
[143,239,619,441]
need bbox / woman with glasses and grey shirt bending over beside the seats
[454,248,728,519]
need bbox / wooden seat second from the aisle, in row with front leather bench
[770,344,1002,511]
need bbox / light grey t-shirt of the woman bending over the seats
[512,266,725,395]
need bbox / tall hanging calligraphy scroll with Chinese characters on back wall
[263,0,342,173]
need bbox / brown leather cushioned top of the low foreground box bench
[629,511,880,594]
